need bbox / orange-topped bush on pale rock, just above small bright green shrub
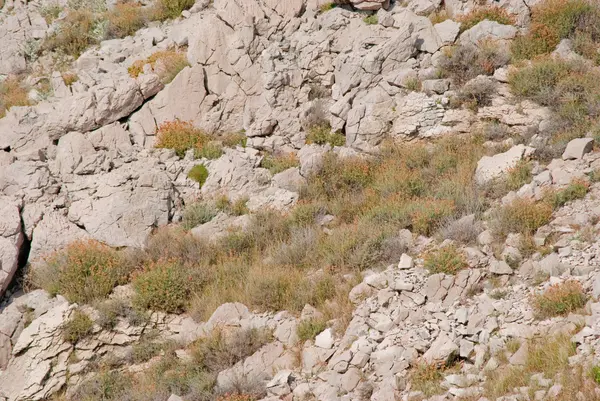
[154,120,208,157]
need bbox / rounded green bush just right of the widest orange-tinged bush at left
[132,261,194,313]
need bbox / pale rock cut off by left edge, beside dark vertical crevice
[0,197,25,297]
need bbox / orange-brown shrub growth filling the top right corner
[511,0,600,60]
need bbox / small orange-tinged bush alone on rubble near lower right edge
[531,281,587,319]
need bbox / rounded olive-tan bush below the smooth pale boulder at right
[492,199,552,236]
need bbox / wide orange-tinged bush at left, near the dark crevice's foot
[31,241,131,303]
